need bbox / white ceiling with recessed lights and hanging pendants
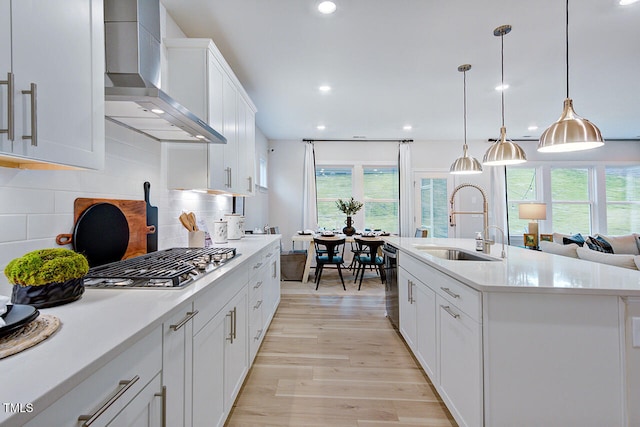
[162,0,640,144]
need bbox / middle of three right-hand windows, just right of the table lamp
[551,168,591,235]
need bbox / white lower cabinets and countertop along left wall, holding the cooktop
[0,235,280,427]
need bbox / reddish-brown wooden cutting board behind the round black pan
[56,197,156,259]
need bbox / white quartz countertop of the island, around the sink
[384,236,640,296]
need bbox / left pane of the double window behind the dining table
[316,167,353,230]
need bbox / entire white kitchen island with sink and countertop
[385,237,640,427]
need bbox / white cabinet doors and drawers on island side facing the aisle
[398,253,483,426]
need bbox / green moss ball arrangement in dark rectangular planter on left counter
[4,248,89,308]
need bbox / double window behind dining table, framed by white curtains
[316,164,399,233]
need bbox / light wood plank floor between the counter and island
[227,271,456,427]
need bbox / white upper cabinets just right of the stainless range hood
[164,39,256,195]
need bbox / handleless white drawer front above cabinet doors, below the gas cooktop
[193,266,248,335]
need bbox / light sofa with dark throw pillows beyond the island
[539,233,640,270]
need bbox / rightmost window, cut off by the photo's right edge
[605,166,640,235]
